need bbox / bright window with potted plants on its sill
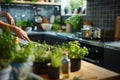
[61,0,87,15]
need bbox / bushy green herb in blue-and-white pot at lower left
[11,38,34,80]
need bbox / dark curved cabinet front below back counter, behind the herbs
[28,34,68,45]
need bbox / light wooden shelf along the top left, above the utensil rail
[0,1,61,6]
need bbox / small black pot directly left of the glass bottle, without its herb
[48,65,60,80]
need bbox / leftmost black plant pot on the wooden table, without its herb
[33,62,48,75]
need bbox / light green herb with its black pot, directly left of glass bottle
[48,46,62,80]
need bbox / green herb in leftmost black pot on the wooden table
[33,42,51,74]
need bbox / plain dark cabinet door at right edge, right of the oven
[104,48,120,73]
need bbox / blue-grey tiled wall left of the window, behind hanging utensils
[1,4,60,21]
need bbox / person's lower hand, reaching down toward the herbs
[12,26,30,41]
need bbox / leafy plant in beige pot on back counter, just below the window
[64,15,82,32]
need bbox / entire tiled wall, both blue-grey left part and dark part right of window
[2,0,120,41]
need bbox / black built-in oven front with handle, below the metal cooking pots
[81,43,104,66]
